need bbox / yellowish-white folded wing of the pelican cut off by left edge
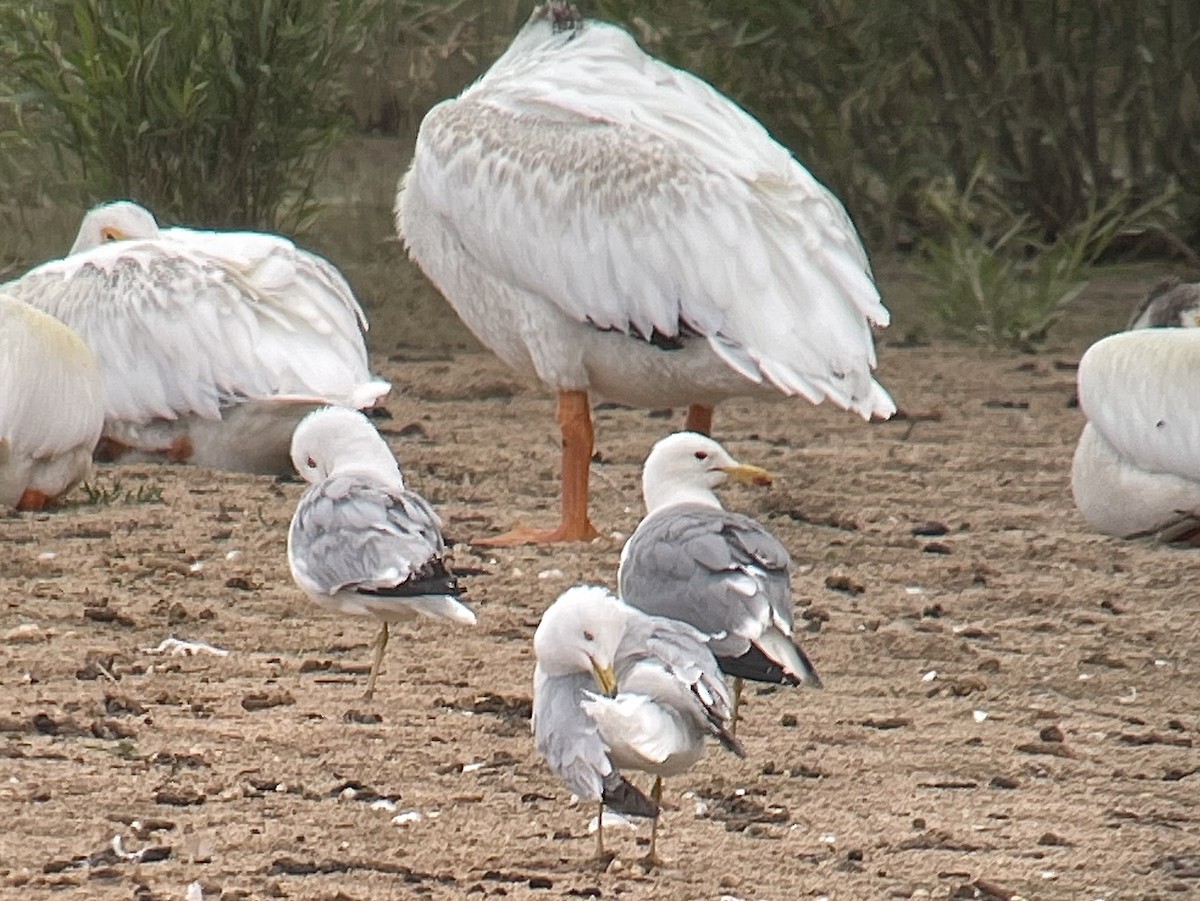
[0,293,104,458]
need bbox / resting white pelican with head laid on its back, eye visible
[4,202,390,475]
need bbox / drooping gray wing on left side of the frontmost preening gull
[533,666,658,817]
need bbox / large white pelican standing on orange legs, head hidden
[396,0,895,543]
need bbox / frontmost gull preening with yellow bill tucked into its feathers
[533,585,744,863]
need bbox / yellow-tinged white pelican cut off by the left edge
[0,292,104,510]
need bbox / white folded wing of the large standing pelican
[398,17,894,416]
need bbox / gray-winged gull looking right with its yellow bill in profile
[617,432,821,726]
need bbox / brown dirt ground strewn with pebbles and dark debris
[0,269,1200,901]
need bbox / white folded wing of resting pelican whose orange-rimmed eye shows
[5,239,386,421]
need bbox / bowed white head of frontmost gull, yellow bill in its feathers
[533,585,634,696]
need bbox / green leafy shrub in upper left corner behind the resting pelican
[0,0,378,227]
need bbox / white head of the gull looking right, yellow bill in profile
[642,432,770,513]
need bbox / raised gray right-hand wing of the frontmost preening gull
[616,617,745,757]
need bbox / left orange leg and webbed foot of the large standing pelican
[473,391,599,547]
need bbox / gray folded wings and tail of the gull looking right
[618,504,820,685]
